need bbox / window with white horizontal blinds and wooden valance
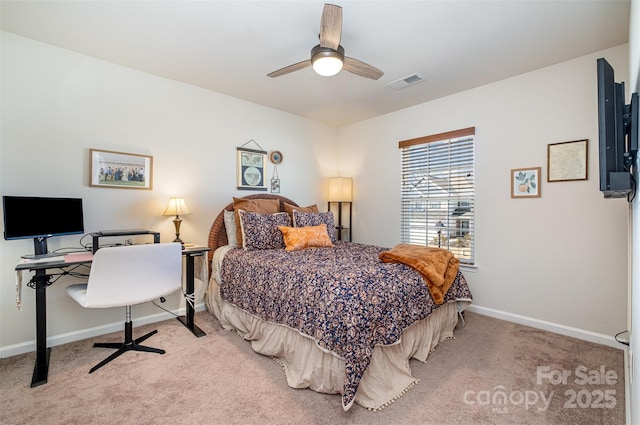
[399,127,475,265]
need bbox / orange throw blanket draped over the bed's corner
[380,243,460,304]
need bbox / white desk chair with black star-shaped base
[67,243,182,373]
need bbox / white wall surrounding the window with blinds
[340,45,628,345]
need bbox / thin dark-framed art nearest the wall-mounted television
[547,139,589,182]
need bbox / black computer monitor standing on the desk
[2,195,84,255]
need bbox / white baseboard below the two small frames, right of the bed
[467,304,625,350]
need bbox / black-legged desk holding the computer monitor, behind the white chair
[16,246,211,387]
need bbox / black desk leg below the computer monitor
[31,270,51,388]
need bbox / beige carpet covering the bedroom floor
[0,310,625,425]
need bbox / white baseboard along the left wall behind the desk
[0,303,206,359]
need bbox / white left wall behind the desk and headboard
[0,32,337,356]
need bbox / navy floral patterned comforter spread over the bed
[219,242,471,409]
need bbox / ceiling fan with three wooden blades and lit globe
[267,3,384,80]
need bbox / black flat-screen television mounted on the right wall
[597,58,640,200]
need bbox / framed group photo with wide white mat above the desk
[89,149,153,190]
